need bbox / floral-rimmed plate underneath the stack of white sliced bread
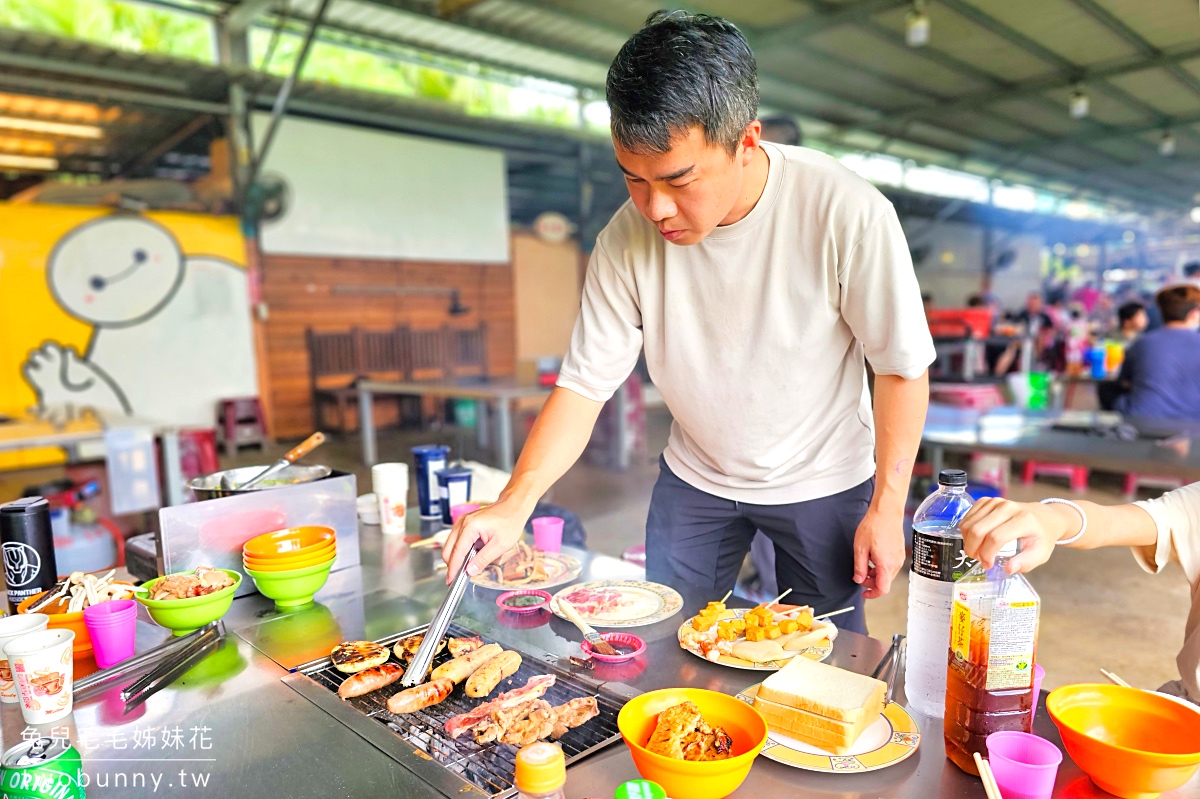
[738,683,920,774]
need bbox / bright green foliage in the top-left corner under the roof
[0,0,214,61]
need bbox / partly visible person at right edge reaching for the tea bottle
[961,482,1200,704]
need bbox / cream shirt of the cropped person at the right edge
[1133,482,1200,703]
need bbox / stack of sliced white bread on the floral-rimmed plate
[758,657,888,723]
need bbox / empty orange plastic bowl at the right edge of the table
[1046,685,1200,799]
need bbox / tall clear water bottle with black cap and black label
[904,469,974,719]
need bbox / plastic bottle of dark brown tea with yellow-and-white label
[943,541,1042,774]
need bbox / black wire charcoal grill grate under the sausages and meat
[283,624,635,799]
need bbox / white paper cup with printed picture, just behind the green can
[4,630,74,725]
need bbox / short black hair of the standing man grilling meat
[605,11,758,155]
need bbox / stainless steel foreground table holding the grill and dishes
[35,513,1200,799]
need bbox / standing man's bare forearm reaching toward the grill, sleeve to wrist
[500,388,604,512]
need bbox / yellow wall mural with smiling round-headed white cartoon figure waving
[0,203,258,441]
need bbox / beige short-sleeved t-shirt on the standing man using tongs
[558,143,935,505]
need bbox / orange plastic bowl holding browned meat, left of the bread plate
[617,689,767,799]
